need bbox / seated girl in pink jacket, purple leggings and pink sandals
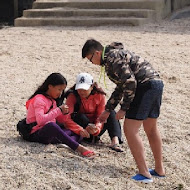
[22,73,94,157]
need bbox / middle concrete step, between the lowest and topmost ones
[23,8,155,18]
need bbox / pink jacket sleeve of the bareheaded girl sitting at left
[34,97,62,125]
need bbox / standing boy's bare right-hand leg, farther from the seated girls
[143,118,165,175]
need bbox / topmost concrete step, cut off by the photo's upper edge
[32,0,159,9]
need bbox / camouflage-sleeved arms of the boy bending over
[106,51,137,111]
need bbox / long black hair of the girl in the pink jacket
[29,73,67,104]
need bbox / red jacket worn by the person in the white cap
[64,93,106,135]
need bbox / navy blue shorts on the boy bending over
[125,80,164,120]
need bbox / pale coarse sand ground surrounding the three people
[0,18,190,190]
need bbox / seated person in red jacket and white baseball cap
[65,73,123,152]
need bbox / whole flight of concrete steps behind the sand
[15,0,165,26]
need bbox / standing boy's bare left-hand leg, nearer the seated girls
[124,119,151,178]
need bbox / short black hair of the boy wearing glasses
[82,39,104,58]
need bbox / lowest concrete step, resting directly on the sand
[15,17,148,27]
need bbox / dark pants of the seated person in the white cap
[73,111,123,143]
